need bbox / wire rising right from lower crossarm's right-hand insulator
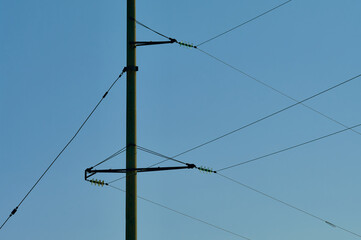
[217,123,361,172]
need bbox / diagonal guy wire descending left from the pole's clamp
[0,68,126,230]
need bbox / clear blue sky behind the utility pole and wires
[0,0,361,240]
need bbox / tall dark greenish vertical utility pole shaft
[125,0,137,240]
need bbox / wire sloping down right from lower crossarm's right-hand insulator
[216,172,361,238]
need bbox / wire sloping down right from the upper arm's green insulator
[197,48,361,135]
